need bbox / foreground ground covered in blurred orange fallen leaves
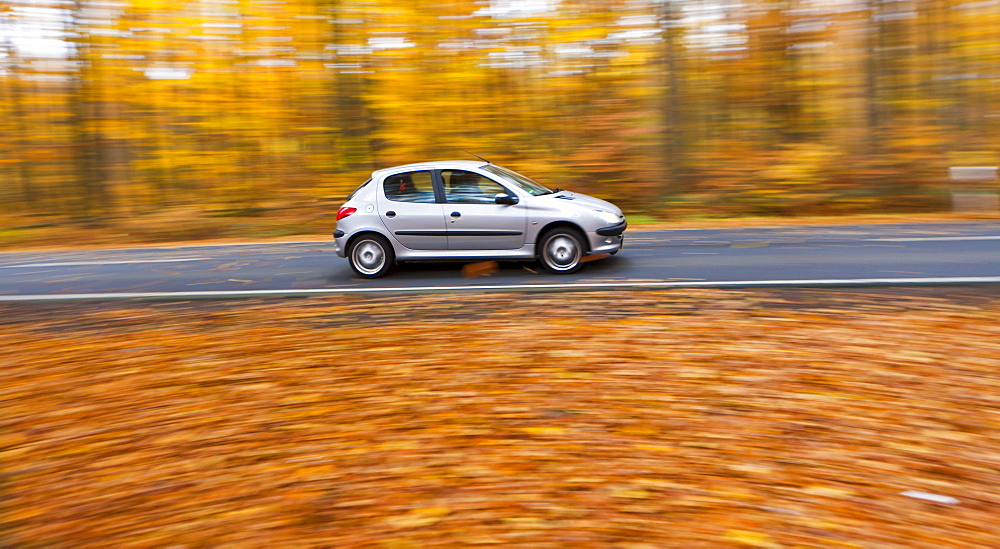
[0,289,1000,548]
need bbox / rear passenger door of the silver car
[378,170,448,250]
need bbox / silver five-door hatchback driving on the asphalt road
[333,160,627,278]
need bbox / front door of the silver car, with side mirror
[441,170,528,250]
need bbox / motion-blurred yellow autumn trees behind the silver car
[0,0,1000,225]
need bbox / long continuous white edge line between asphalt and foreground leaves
[0,276,1000,302]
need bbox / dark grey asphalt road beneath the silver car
[0,222,1000,301]
